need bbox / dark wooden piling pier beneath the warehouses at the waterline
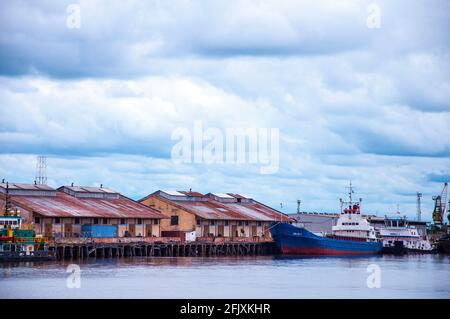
[49,242,276,259]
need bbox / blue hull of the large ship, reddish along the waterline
[270,223,383,256]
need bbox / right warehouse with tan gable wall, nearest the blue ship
[140,190,290,240]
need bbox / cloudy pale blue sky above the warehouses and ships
[0,0,450,220]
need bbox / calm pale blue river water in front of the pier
[0,255,450,298]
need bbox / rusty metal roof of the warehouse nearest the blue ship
[151,192,290,221]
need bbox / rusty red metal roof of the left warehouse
[7,191,165,219]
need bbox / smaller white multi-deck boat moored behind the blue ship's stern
[379,216,435,255]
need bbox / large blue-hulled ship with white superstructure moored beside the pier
[270,182,383,256]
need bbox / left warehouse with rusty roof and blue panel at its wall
[0,183,165,238]
